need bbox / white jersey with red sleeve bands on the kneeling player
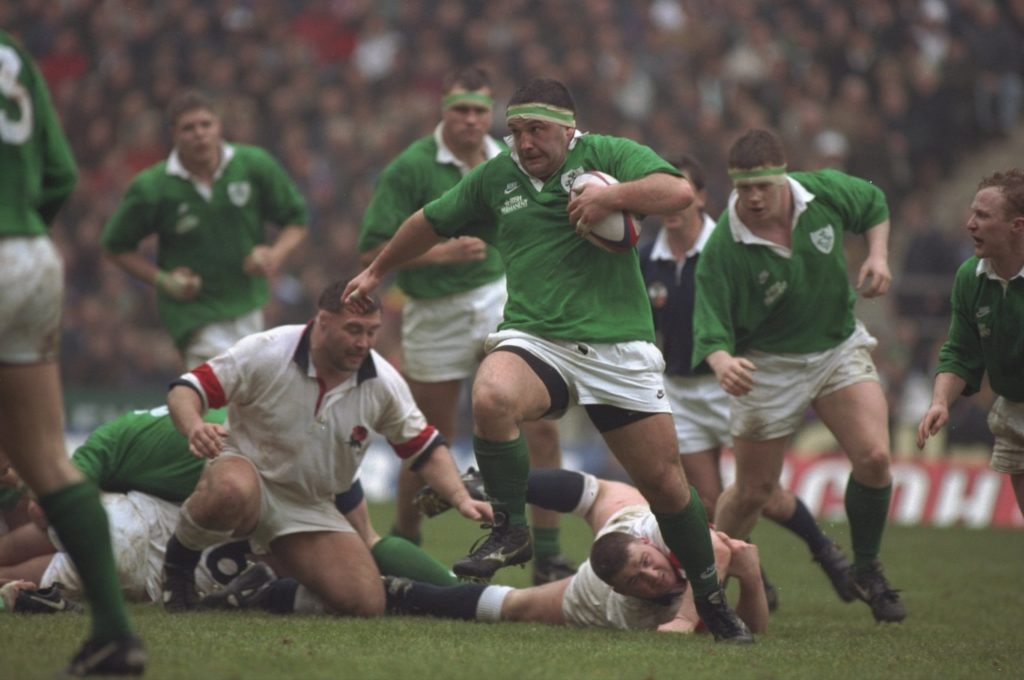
[179,324,439,500]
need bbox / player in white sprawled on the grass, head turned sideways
[385,470,768,633]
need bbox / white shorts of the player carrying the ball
[484,330,672,413]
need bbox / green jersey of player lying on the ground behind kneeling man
[71,407,227,503]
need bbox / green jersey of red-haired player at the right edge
[935,257,1024,402]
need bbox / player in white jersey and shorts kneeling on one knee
[163,281,493,615]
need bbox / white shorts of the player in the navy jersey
[665,374,732,454]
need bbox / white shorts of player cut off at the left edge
[0,236,63,364]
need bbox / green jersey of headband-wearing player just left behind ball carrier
[358,127,505,299]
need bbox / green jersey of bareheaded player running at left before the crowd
[100,144,308,348]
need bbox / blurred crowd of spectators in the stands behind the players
[0,0,1024,454]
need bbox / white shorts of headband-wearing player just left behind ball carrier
[401,277,508,383]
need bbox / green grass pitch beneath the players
[0,506,1024,680]
